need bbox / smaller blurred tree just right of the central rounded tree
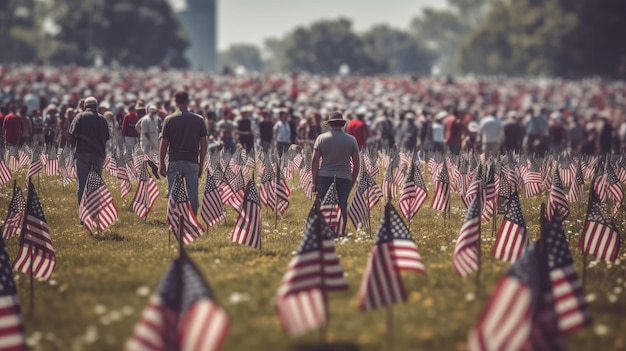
[363,25,436,74]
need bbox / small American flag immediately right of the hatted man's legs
[348,168,382,228]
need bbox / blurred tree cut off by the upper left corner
[0,0,39,62]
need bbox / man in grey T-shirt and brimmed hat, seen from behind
[311,111,361,234]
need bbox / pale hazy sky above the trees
[170,0,447,50]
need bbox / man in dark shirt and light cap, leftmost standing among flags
[69,96,110,204]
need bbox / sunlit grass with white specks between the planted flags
[0,169,626,350]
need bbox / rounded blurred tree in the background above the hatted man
[282,18,387,74]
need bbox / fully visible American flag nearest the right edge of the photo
[578,189,620,262]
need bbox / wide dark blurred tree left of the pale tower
[52,0,188,67]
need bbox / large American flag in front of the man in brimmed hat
[276,207,348,336]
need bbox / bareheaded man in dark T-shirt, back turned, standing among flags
[159,91,207,214]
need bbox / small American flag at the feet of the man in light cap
[78,170,117,233]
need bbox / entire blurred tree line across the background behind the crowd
[0,0,626,78]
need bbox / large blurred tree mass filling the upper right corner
[460,0,626,78]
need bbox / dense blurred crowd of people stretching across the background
[0,65,626,160]
